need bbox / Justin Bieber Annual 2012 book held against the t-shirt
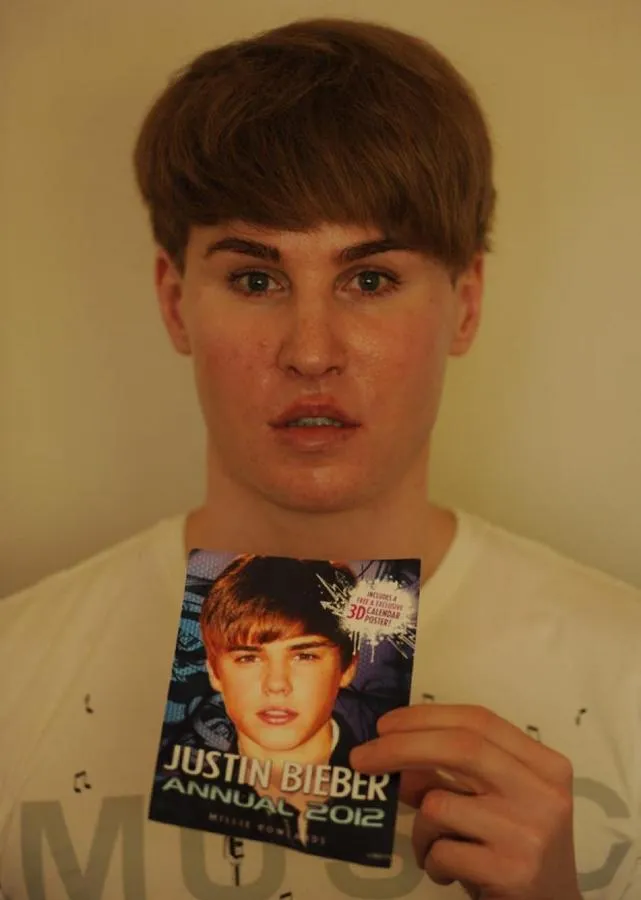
[149,550,420,867]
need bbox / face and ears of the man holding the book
[156,222,483,512]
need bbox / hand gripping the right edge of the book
[350,703,581,900]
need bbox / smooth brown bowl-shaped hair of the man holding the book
[134,18,495,276]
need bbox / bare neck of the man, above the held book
[185,458,456,582]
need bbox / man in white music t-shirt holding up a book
[0,14,641,900]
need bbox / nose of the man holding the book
[278,289,347,378]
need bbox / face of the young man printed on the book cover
[209,635,356,751]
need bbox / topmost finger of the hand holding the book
[377,703,569,783]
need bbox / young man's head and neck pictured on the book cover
[200,556,362,765]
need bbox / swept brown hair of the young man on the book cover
[200,554,356,670]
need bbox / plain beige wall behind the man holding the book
[0,0,641,594]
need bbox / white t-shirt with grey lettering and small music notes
[0,513,641,900]
